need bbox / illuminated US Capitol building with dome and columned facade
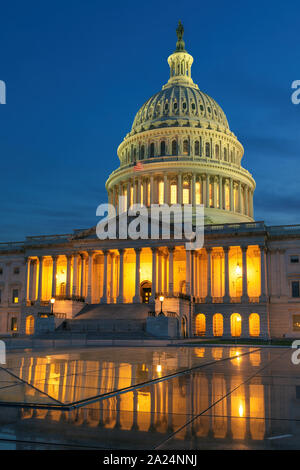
[0,23,300,338]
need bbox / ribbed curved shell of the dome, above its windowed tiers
[131,85,229,133]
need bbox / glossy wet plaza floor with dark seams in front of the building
[0,345,300,450]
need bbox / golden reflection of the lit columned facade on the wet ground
[2,347,288,441]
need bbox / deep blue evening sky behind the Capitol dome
[0,0,300,241]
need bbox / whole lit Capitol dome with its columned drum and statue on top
[106,25,255,223]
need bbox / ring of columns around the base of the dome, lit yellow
[109,173,253,217]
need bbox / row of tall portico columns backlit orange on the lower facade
[26,246,266,303]
